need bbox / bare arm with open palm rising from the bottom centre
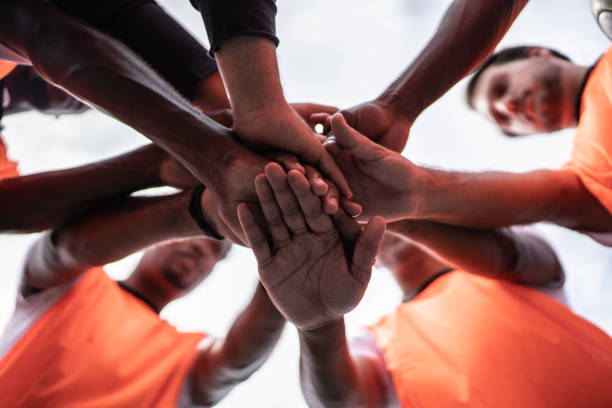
[238,164,385,407]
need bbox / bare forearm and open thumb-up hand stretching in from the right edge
[329,114,612,231]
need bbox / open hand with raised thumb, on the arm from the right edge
[326,113,416,220]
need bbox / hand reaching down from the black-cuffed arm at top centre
[233,103,352,198]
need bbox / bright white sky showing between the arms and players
[0,0,612,407]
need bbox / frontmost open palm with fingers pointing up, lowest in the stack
[238,163,385,329]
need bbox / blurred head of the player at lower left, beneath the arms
[133,237,231,305]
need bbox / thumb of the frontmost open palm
[351,215,386,284]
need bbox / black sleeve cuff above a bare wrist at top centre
[190,0,278,56]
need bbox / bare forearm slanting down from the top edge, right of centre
[378,0,528,122]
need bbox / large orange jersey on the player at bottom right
[370,271,612,408]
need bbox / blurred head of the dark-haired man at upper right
[466,46,576,136]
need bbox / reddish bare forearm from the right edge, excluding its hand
[405,167,612,231]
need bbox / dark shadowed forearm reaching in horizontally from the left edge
[0,145,166,232]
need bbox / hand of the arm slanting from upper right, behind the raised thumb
[310,101,412,152]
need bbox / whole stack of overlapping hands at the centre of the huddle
[167,99,411,330]
